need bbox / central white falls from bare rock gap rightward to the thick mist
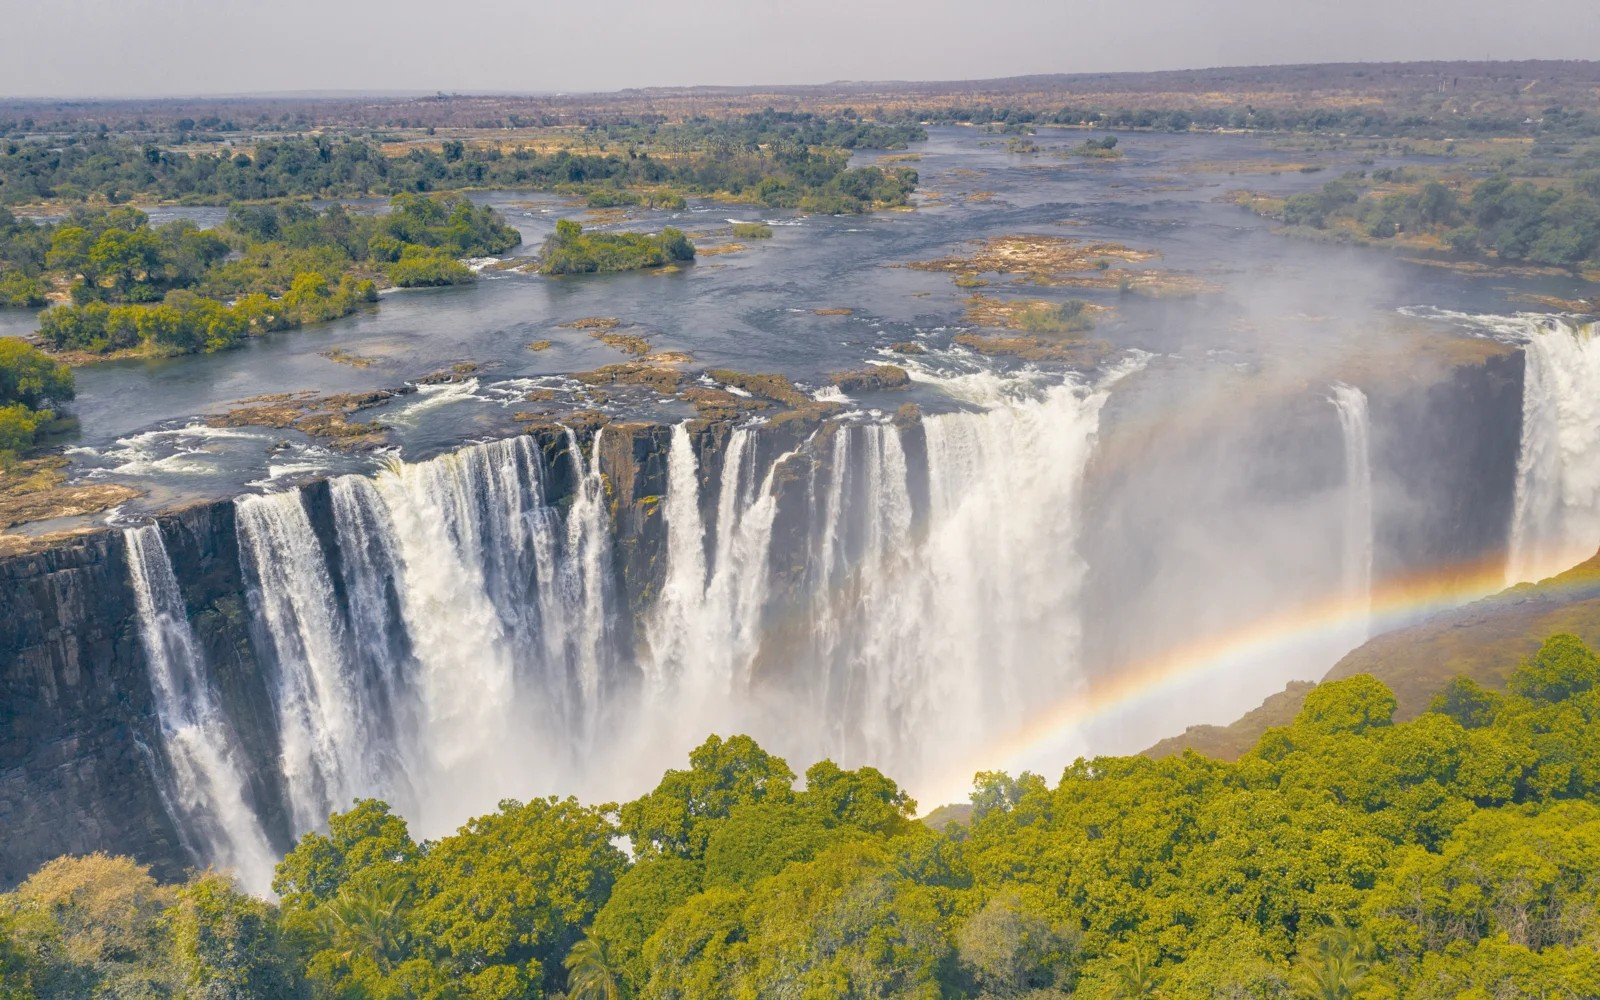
[643,376,1106,786]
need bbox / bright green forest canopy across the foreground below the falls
[0,635,1600,1000]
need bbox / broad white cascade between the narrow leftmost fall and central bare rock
[237,434,616,832]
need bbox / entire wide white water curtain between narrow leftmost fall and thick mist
[147,368,1109,856]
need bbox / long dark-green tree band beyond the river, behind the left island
[0,130,917,214]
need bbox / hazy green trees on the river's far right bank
[1240,168,1600,267]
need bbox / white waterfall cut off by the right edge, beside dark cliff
[1506,317,1600,582]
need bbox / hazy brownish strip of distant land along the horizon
[0,59,1600,131]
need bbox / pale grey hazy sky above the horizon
[0,0,1600,98]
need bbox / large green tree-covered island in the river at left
[0,194,520,355]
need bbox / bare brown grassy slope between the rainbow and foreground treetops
[1144,554,1600,760]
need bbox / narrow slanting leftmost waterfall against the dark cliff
[123,525,277,893]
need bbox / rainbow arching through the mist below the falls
[925,555,1576,808]
